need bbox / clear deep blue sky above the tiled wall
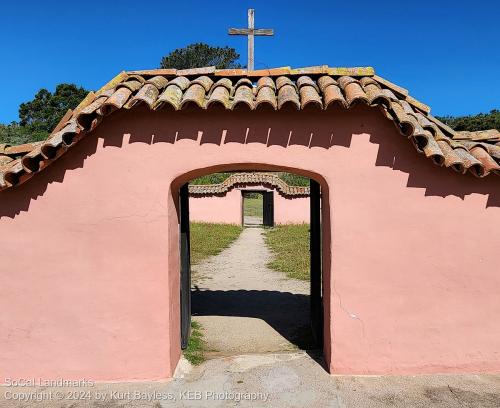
[0,0,500,123]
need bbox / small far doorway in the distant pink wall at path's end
[241,190,274,227]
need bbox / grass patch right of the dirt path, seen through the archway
[266,224,310,280]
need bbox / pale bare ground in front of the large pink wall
[0,352,500,408]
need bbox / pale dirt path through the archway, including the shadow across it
[192,228,312,356]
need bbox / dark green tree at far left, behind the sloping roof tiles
[19,84,88,133]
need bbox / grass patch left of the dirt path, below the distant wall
[190,222,242,265]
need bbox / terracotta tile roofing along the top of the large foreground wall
[0,66,500,190]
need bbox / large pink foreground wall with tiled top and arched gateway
[0,66,500,380]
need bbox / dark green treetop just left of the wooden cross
[160,43,241,69]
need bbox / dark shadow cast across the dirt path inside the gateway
[191,286,317,350]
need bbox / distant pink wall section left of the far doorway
[189,189,241,225]
